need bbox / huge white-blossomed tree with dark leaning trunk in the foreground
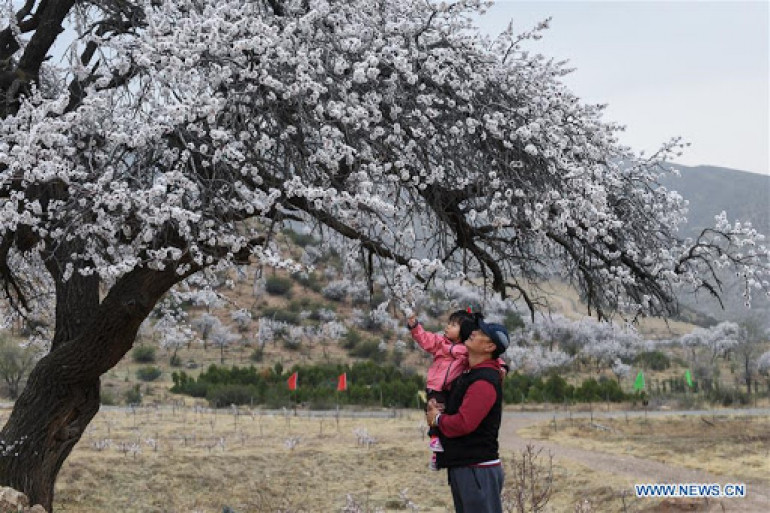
[0,0,768,509]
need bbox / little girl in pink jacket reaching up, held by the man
[407,308,488,470]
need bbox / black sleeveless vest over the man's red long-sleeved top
[436,367,503,468]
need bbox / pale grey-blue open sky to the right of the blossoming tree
[478,0,770,174]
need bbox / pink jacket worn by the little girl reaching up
[410,323,468,390]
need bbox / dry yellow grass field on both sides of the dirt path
[0,406,770,513]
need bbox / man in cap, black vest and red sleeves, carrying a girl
[427,320,509,513]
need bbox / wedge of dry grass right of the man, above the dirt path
[520,416,770,481]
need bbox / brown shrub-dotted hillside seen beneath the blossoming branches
[93,231,694,403]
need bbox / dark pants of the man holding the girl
[448,465,504,513]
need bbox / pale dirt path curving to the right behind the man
[500,412,770,513]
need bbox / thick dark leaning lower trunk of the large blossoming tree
[0,269,189,512]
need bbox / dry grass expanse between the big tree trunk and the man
[48,408,451,513]
